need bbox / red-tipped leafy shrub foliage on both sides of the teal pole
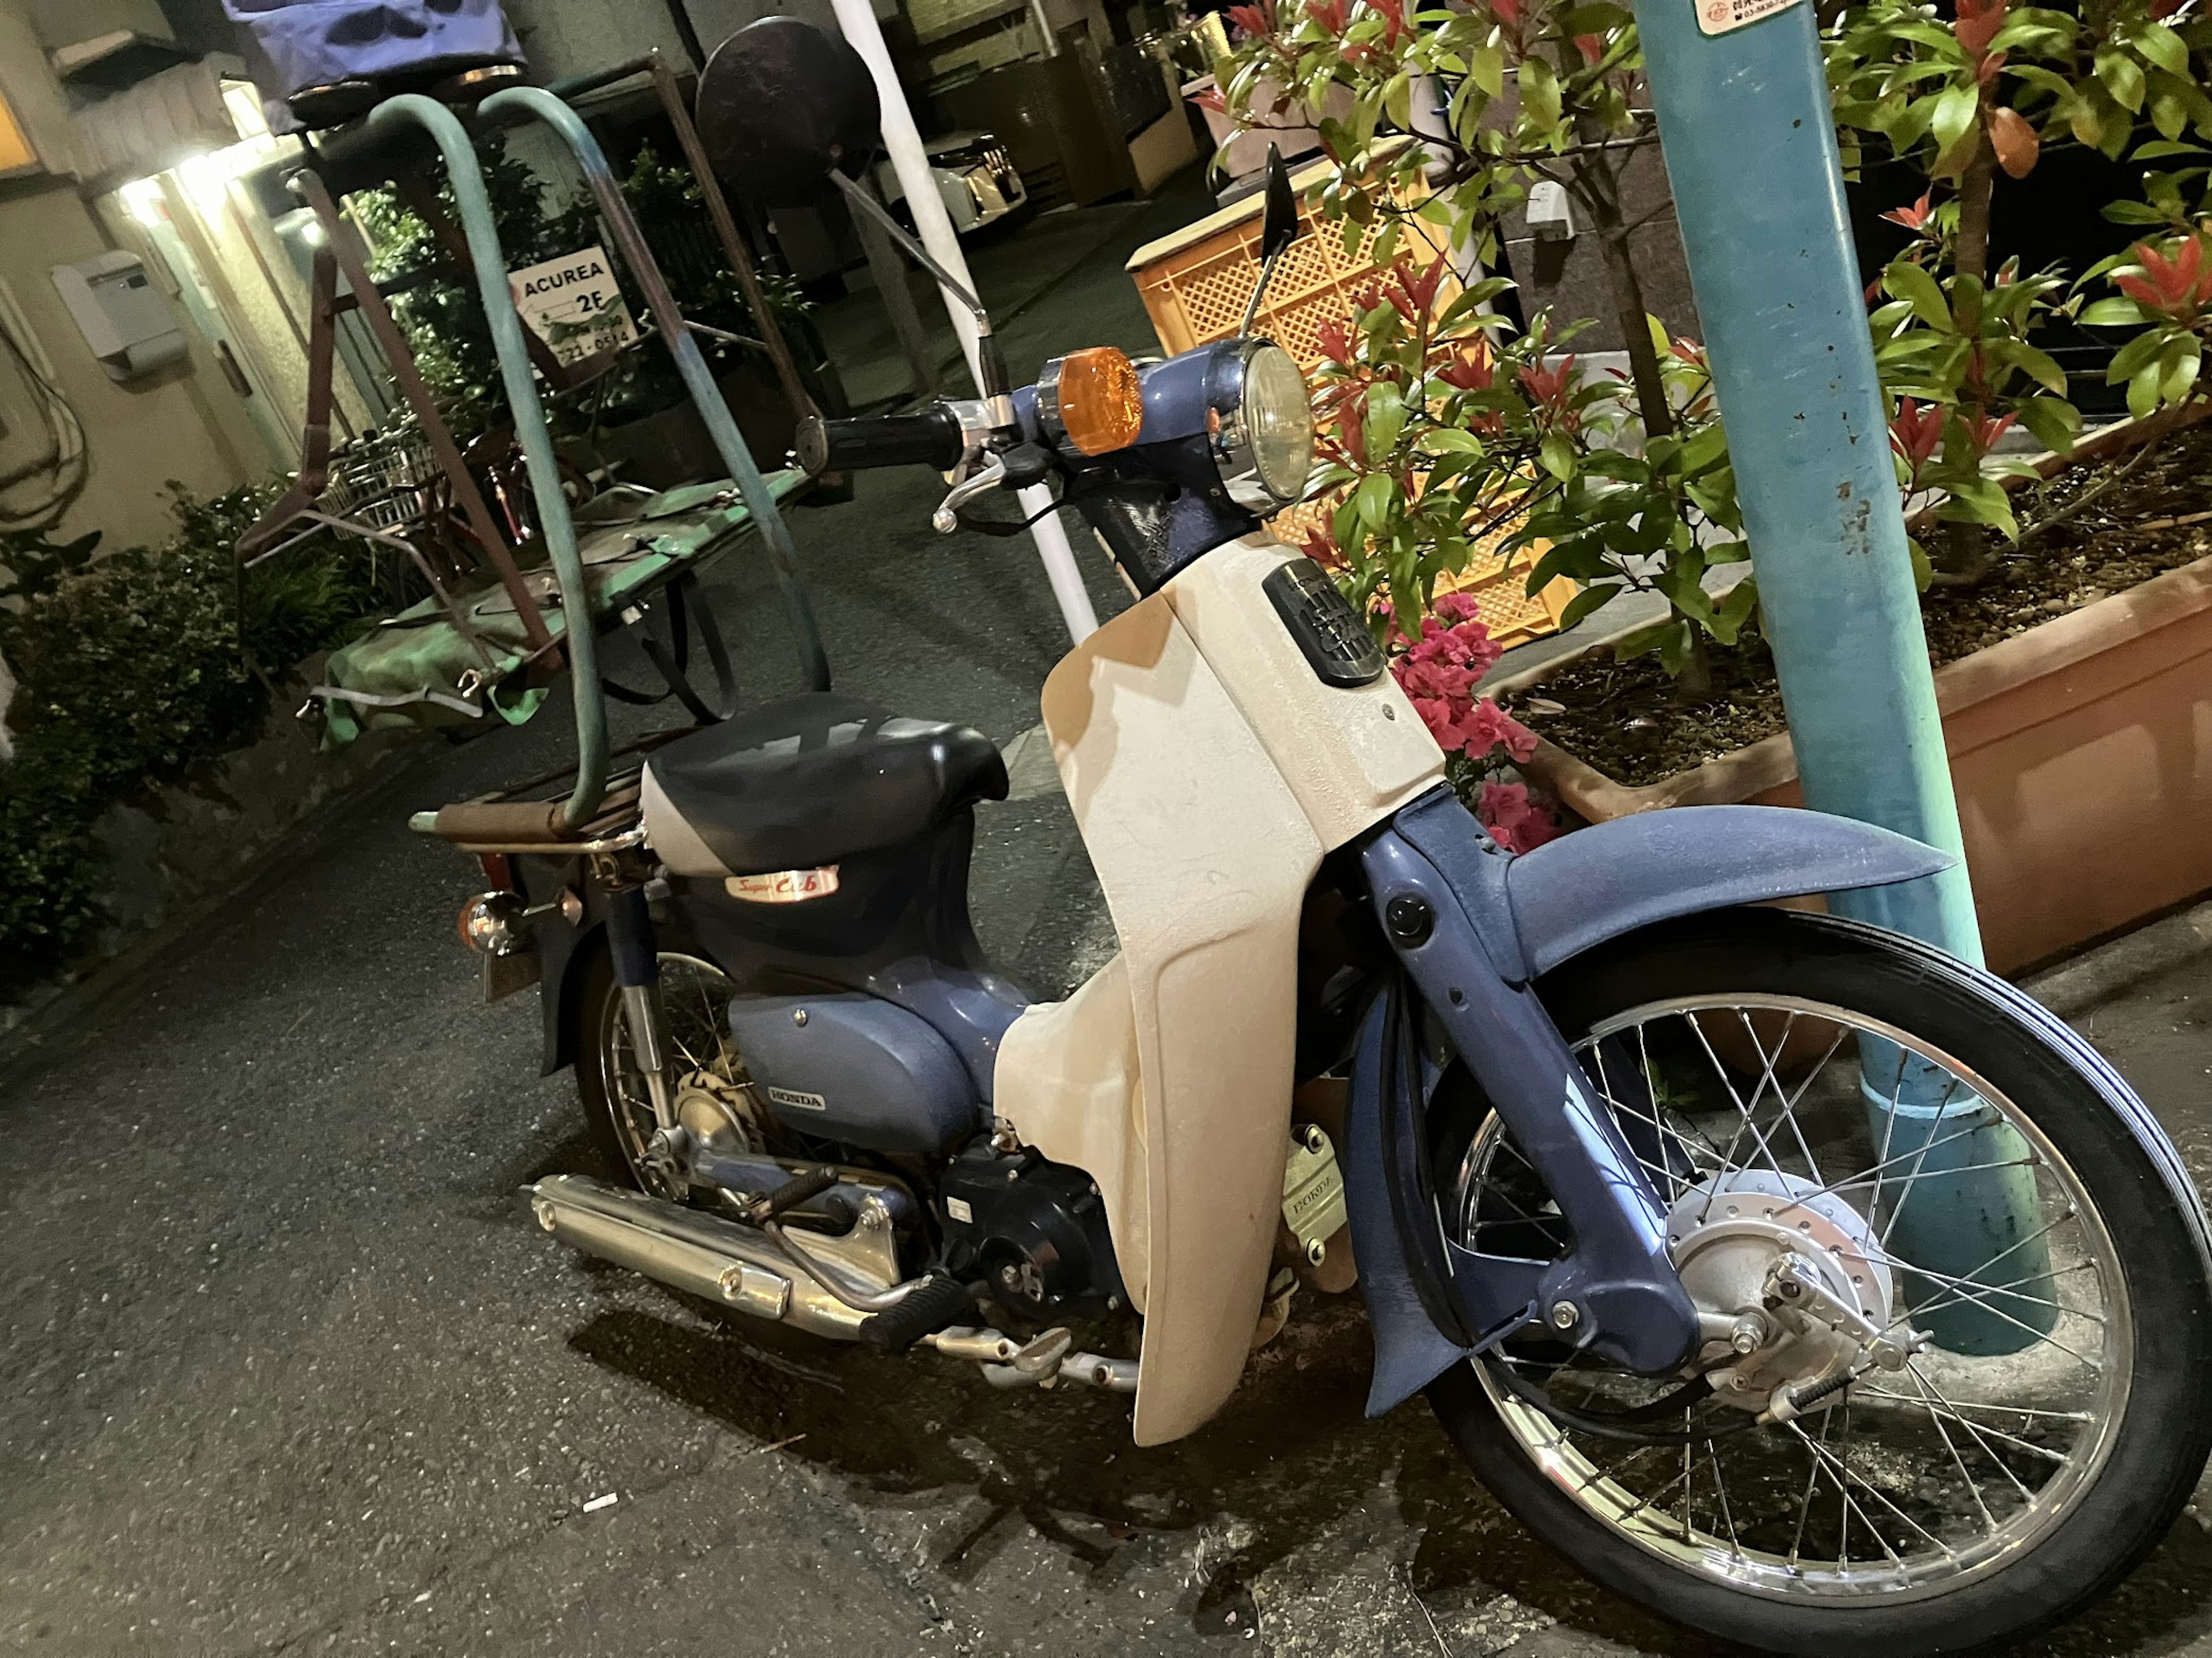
[1219,0,2212,671]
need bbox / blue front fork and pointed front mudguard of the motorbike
[1343,789,1953,1415]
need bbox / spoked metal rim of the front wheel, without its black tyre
[1453,995,2130,1596]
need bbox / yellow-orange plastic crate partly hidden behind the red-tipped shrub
[1128,161,1575,646]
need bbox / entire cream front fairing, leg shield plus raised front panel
[995,537,1445,1444]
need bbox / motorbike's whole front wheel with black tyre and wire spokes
[1429,911,2212,1658]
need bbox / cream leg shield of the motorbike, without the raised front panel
[998,595,1320,1445]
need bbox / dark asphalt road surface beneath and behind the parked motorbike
[0,172,2212,1658]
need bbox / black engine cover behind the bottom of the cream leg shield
[938,1141,1128,1320]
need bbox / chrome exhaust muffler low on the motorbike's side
[529,1174,898,1342]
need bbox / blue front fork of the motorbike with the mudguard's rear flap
[1345,829,1696,1413]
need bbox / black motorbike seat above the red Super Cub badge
[646,692,1006,875]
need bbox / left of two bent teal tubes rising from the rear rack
[369,93,606,827]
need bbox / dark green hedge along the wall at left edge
[0,484,382,993]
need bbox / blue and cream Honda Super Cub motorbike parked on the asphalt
[418,20,2212,1658]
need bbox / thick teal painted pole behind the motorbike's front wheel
[1637,0,2044,1353]
